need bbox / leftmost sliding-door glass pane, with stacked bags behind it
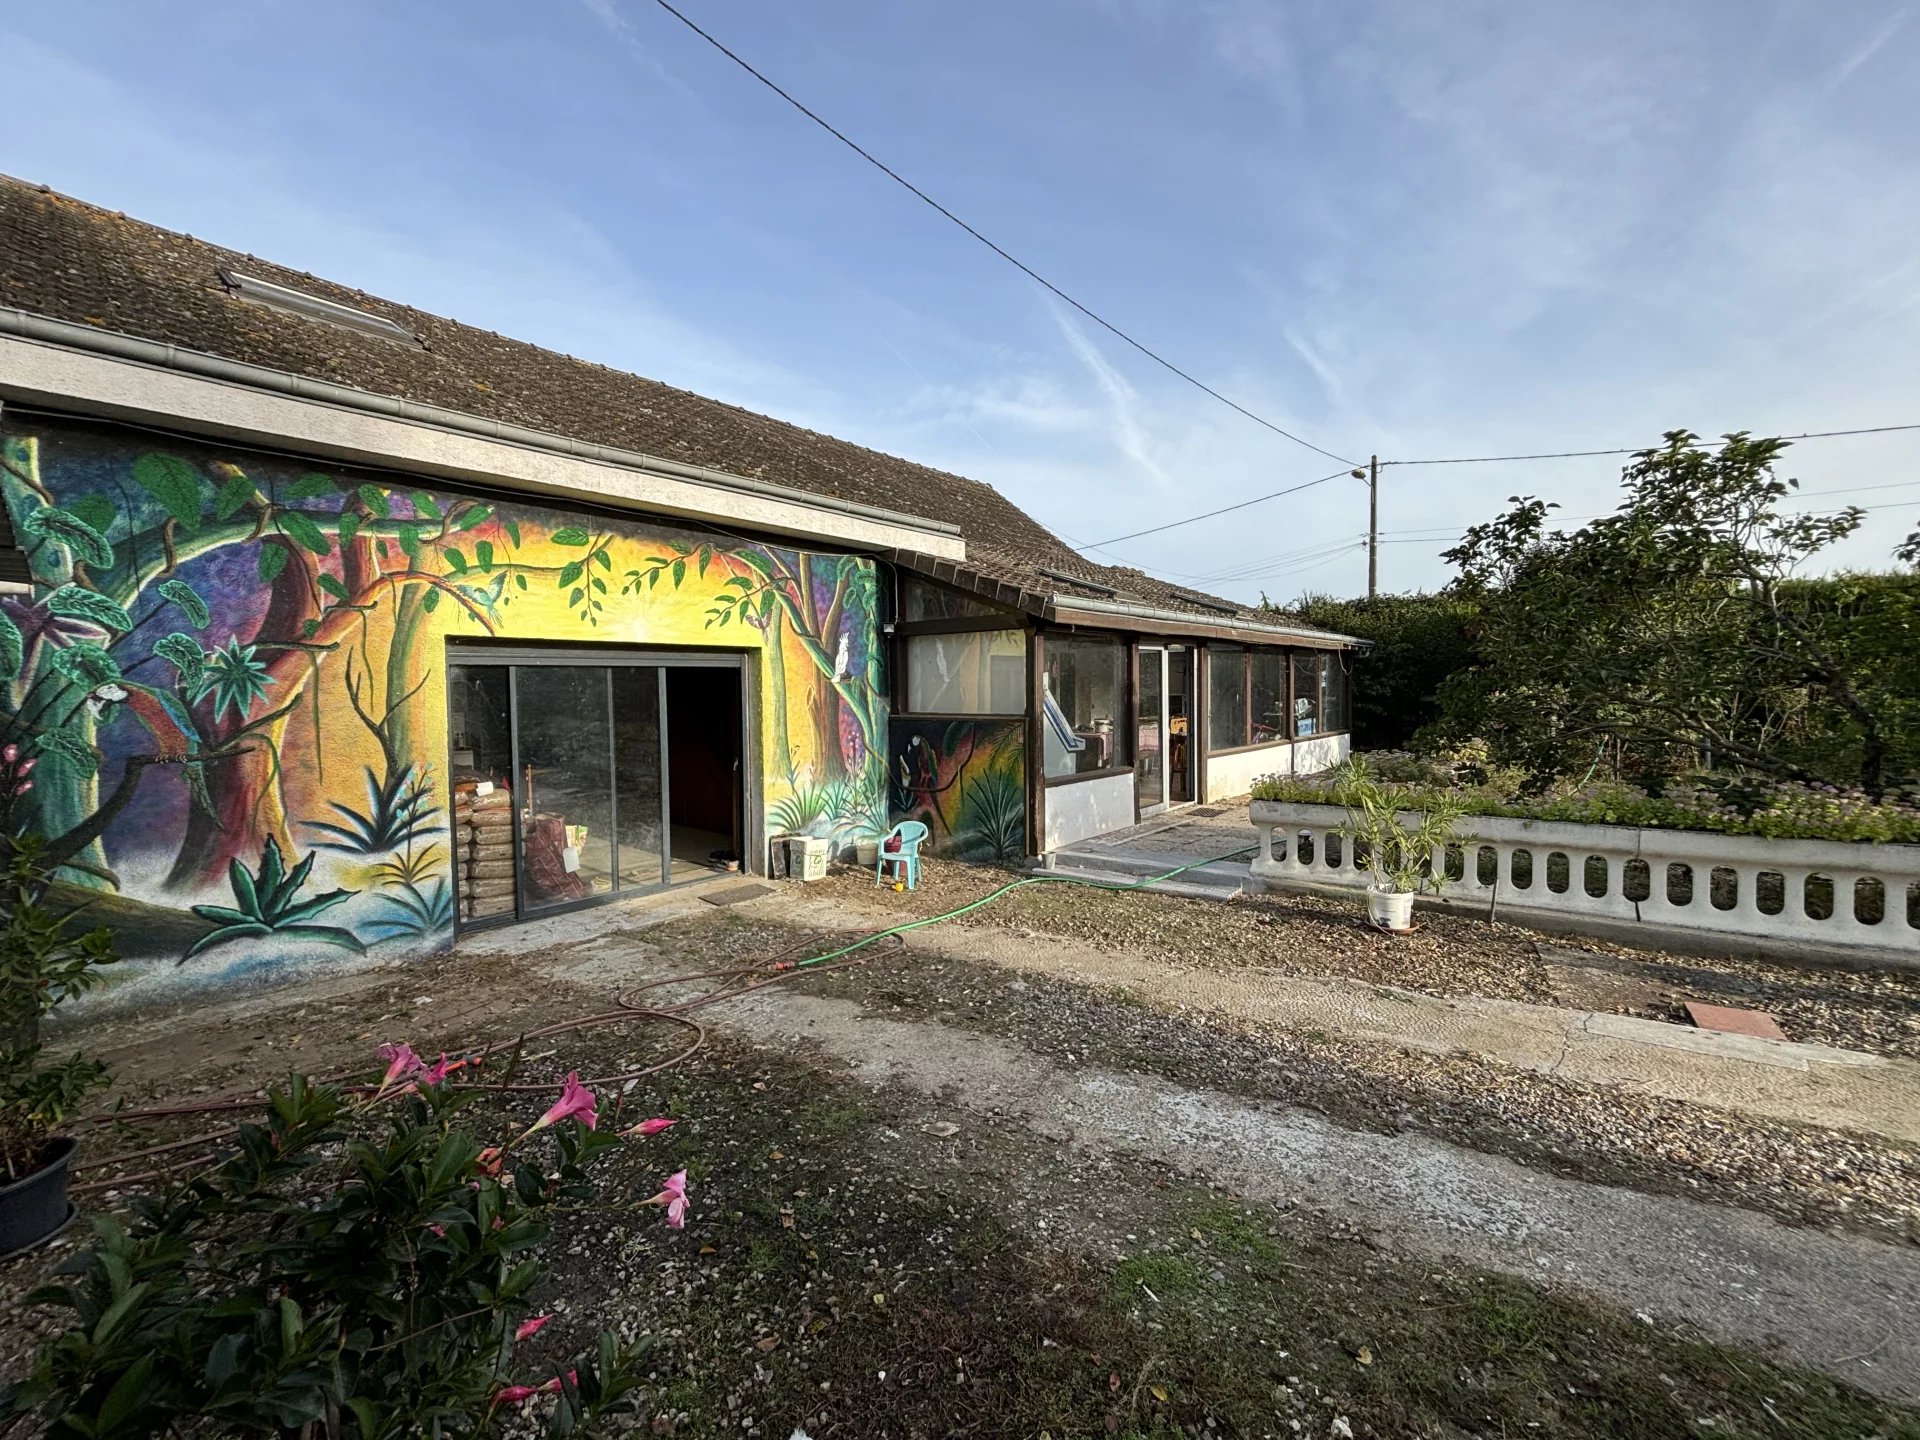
[447,664,513,920]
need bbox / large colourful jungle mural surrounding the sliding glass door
[0,419,887,973]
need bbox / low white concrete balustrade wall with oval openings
[1250,801,1920,964]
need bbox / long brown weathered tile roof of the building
[0,177,1351,637]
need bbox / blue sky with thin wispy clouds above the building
[0,0,1920,599]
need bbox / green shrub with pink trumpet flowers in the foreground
[0,1046,685,1440]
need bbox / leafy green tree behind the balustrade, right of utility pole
[1442,430,1899,795]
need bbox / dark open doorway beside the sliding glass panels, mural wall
[666,666,745,881]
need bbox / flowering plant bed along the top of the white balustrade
[1252,751,1920,845]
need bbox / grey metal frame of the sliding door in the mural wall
[442,639,766,939]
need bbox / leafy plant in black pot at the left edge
[0,839,119,1258]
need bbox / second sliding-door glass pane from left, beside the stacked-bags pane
[513,664,612,910]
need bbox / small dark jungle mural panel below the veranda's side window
[887,718,1027,864]
